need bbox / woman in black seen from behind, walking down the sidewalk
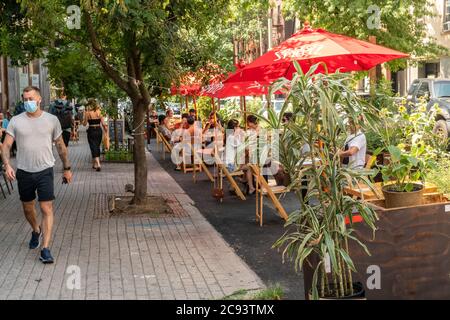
[83,99,108,171]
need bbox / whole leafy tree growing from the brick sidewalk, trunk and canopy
[0,0,232,199]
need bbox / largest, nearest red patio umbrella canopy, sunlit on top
[225,26,408,83]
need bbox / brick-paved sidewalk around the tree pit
[0,132,264,300]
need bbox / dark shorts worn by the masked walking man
[16,168,55,202]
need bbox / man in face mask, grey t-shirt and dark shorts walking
[1,87,72,263]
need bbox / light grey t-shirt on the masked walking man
[6,111,62,172]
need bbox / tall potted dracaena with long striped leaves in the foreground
[261,63,377,299]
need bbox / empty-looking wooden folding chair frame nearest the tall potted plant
[248,164,288,226]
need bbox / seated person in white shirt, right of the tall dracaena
[338,119,367,169]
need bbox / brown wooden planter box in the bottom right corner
[350,195,450,299]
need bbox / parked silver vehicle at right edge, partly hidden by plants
[406,79,450,140]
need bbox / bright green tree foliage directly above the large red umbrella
[283,0,447,71]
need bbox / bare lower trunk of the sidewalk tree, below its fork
[133,99,147,205]
